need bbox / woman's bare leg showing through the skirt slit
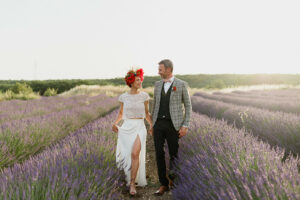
[130,135,141,189]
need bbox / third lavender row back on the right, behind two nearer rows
[194,92,300,115]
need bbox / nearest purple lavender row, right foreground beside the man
[172,113,300,200]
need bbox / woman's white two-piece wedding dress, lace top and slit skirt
[116,92,150,186]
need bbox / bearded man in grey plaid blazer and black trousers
[150,59,192,196]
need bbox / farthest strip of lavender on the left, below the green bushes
[0,94,108,124]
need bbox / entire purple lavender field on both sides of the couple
[0,88,300,200]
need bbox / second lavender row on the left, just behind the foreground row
[0,95,118,169]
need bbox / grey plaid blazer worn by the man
[151,77,192,130]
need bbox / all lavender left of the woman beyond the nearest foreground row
[0,95,118,169]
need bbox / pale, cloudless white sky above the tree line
[0,0,300,80]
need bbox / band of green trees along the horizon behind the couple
[0,74,300,94]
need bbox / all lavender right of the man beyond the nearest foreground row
[192,89,300,155]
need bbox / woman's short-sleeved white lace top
[119,91,150,119]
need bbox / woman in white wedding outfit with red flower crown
[112,69,152,195]
